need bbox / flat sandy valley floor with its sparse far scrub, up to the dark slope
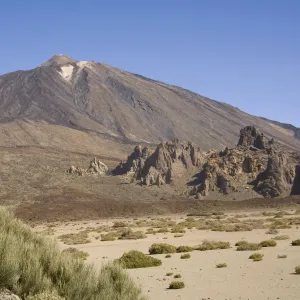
[35,208,300,300]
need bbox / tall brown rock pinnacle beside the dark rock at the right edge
[254,153,294,197]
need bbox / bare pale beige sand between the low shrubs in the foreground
[37,211,300,300]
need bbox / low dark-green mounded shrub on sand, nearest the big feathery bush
[117,250,161,269]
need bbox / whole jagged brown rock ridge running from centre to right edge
[112,126,300,199]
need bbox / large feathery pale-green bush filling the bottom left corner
[0,209,142,300]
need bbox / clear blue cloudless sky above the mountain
[0,0,300,127]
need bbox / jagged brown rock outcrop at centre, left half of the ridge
[113,140,202,185]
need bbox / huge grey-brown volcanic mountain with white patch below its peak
[0,55,300,150]
